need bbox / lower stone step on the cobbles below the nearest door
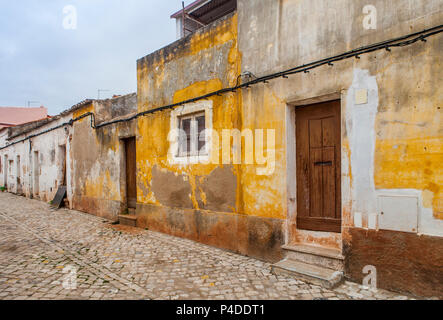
[271,258,344,289]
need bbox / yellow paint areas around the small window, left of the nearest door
[137,16,285,219]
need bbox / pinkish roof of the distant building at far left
[0,106,48,130]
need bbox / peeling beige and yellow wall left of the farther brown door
[72,94,137,221]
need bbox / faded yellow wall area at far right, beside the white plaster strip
[374,47,443,219]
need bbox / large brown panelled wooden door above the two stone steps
[296,101,341,232]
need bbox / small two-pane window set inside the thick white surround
[178,112,207,157]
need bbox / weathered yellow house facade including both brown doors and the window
[0,0,443,297]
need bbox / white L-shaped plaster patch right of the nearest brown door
[346,69,443,236]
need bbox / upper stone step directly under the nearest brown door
[283,244,344,271]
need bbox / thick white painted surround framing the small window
[168,100,213,164]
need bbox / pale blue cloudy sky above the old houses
[0,0,185,115]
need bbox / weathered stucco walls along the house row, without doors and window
[0,0,443,295]
